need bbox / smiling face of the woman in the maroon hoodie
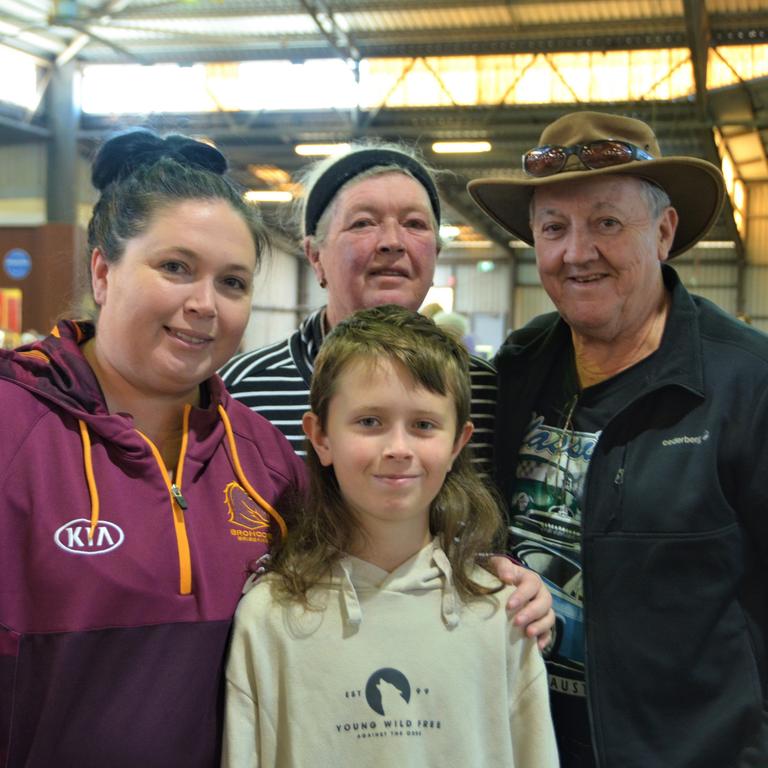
[91,199,256,397]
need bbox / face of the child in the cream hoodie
[305,360,472,544]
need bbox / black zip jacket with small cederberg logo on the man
[496,266,768,768]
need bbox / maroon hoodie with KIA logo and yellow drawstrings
[0,322,304,768]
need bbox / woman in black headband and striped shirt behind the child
[221,144,554,644]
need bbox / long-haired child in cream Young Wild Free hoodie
[223,306,558,768]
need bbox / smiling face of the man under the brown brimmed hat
[531,175,676,341]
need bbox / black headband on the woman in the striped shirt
[304,149,440,235]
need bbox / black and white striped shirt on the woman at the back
[219,307,496,471]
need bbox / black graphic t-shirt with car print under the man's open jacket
[509,358,651,768]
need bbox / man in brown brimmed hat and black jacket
[469,112,768,768]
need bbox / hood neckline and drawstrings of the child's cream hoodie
[330,539,460,628]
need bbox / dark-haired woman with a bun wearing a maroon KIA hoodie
[0,131,303,768]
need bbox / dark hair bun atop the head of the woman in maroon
[91,128,227,191]
